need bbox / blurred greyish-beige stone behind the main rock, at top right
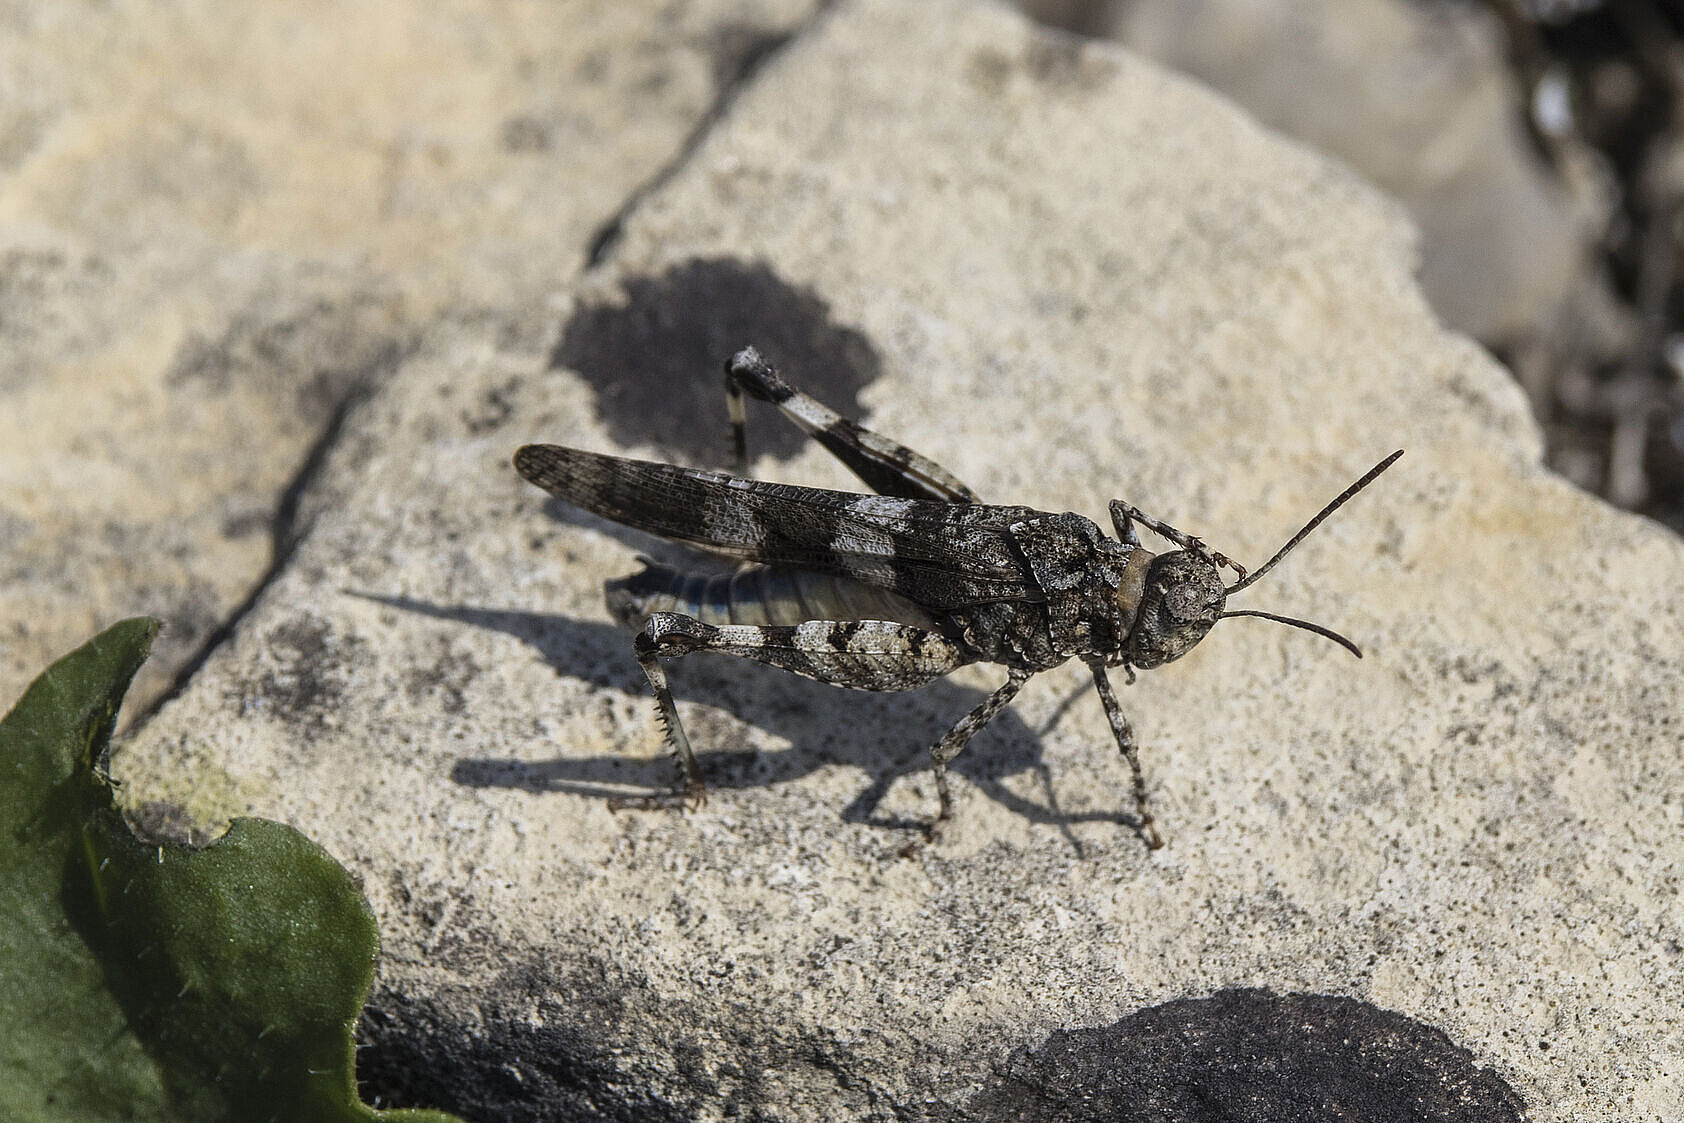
[1106,0,1600,343]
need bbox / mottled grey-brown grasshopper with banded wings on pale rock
[514,347,1403,849]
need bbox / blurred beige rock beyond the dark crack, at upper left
[0,0,813,720]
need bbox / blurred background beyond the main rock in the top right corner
[1021,0,1684,532]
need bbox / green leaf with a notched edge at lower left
[0,620,451,1123]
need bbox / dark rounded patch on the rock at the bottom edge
[967,988,1527,1123]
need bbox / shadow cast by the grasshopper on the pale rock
[357,589,1135,828]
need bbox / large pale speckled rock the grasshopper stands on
[108,0,1684,1121]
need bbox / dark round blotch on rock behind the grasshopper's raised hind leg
[551,258,882,466]
